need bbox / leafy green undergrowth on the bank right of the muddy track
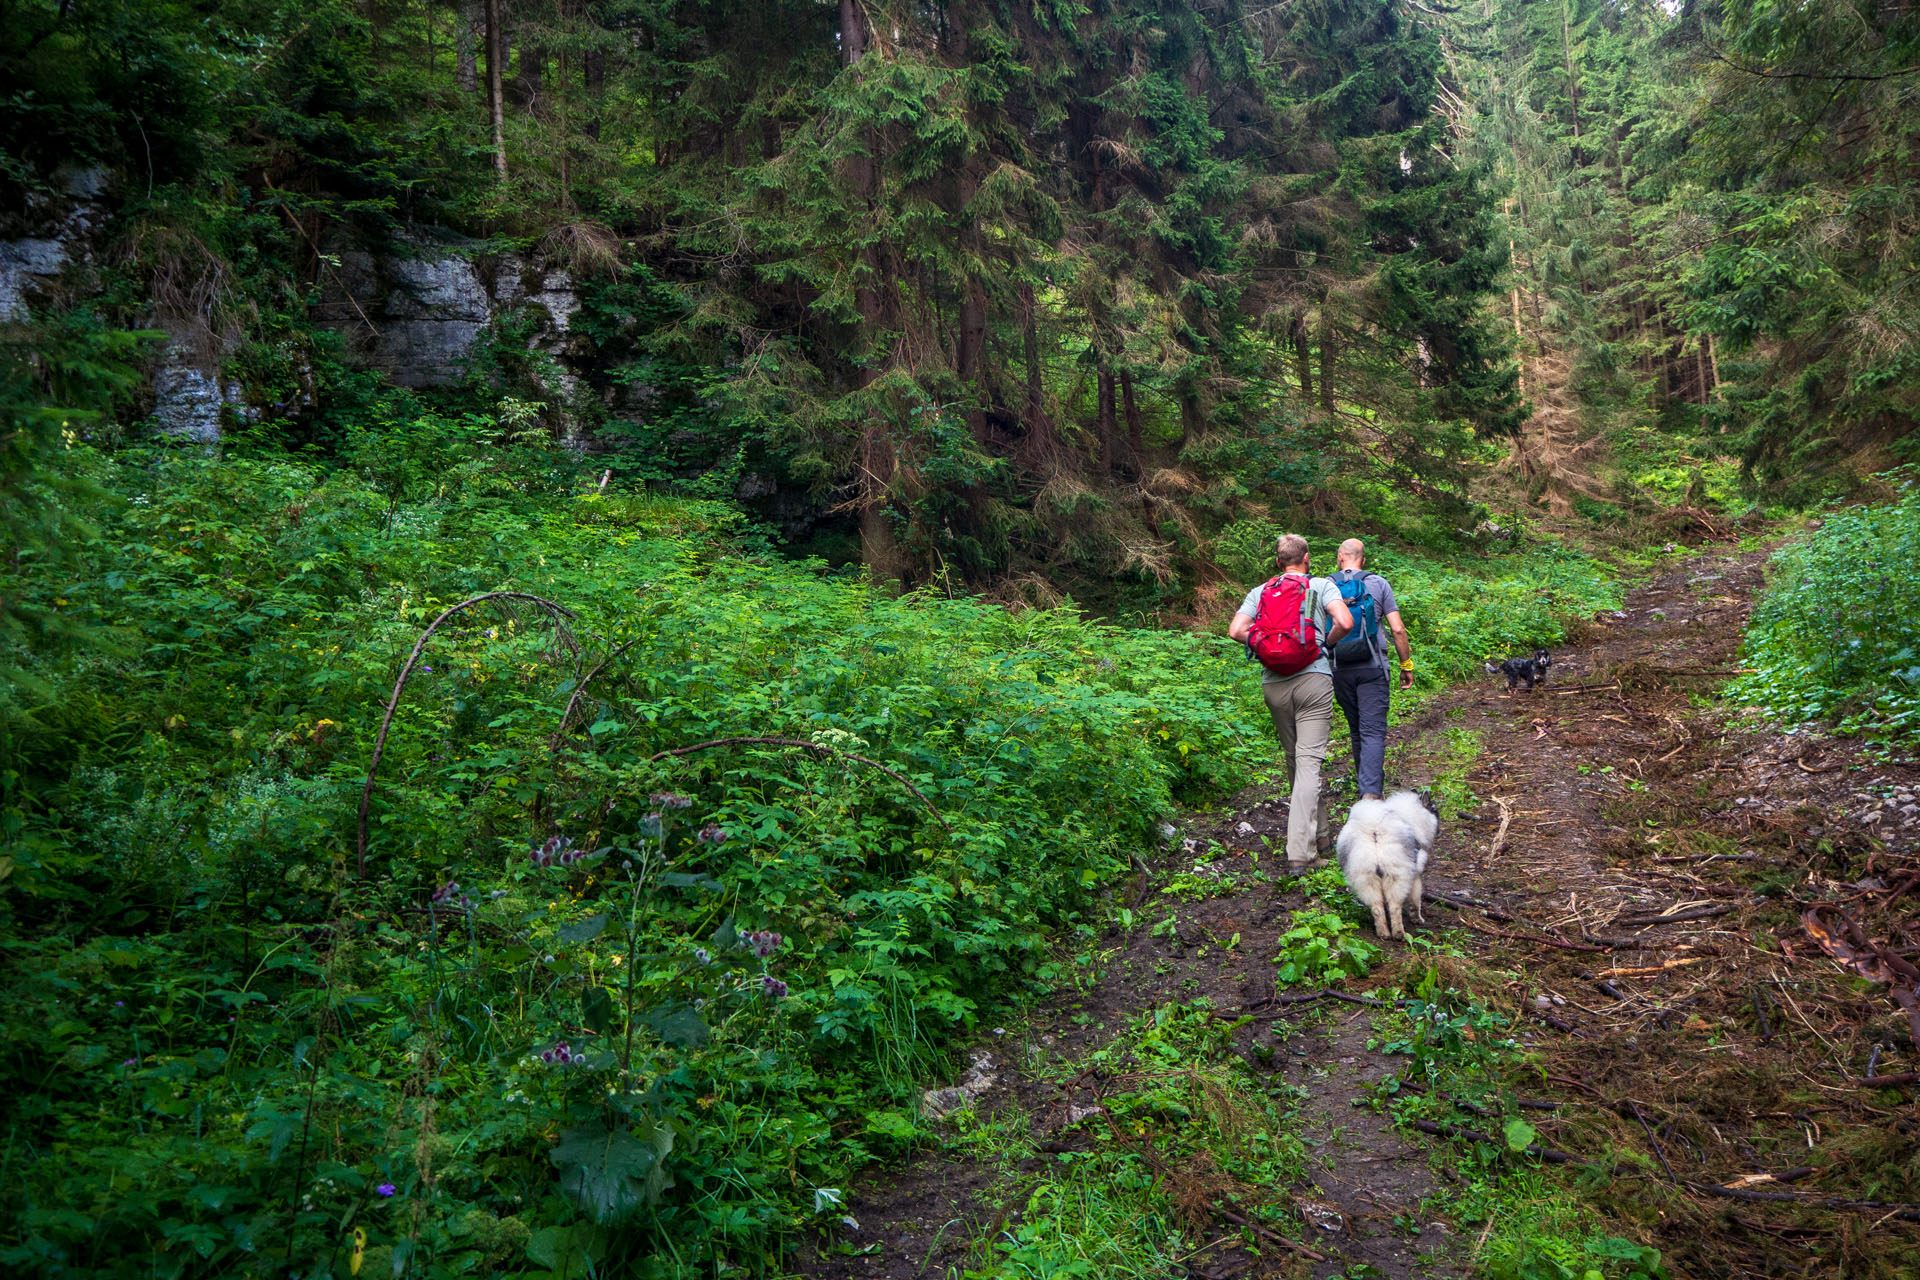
[1728,470,1920,754]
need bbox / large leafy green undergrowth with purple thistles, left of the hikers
[0,437,1271,1278]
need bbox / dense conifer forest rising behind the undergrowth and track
[0,0,1914,608]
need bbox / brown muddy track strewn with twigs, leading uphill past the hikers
[795,551,1920,1280]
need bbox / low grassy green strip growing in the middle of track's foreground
[944,1002,1308,1280]
